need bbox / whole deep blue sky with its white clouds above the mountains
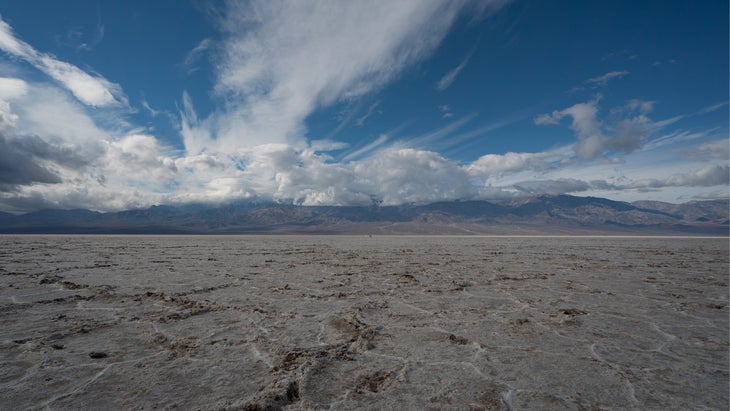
[0,0,730,213]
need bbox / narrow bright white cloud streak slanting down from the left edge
[0,20,127,107]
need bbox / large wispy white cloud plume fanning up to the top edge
[181,0,504,152]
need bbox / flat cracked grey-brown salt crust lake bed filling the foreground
[0,236,729,410]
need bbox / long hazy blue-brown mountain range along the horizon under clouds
[0,195,730,236]
